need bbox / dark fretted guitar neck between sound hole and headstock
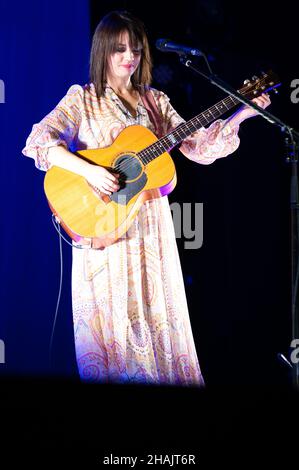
[138,90,240,164]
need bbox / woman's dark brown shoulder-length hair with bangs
[89,11,152,97]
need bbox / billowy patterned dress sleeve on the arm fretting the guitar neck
[157,92,240,165]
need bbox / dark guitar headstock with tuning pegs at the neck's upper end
[238,70,281,100]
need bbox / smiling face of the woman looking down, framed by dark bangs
[107,32,142,80]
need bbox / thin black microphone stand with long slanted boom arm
[180,54,299,389]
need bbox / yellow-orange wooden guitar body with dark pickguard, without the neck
[44,125,176,248]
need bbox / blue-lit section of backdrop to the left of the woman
[0,0,90,375]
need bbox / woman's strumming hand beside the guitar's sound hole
[84,164,119,196]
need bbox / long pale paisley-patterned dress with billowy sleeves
[23,83,239,386]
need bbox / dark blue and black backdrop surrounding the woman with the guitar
[0,0,299,390]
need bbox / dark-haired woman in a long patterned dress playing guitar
[23,12,270,386]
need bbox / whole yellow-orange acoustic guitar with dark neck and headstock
[44,71,280,249]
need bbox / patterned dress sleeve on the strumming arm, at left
[22,85,83,171]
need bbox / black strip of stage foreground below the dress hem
[0,377,299,468]
